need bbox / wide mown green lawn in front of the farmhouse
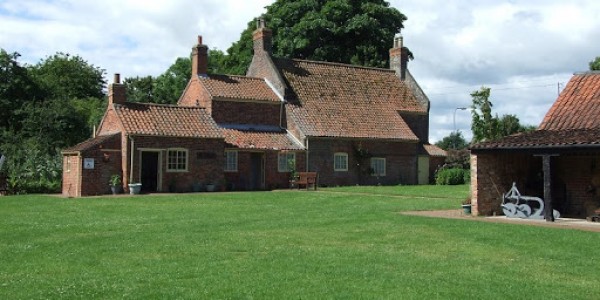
[0,186,600,299]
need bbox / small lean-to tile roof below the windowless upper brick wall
[223,129,304,150]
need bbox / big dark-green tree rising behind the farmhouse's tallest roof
[218,0,406,74]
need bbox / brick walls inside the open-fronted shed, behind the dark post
[471,153,600,217]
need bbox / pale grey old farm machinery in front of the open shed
[502,182,560,219]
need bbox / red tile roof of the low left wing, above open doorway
[114,102,223,138]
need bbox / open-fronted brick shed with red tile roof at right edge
[471,71,600,217]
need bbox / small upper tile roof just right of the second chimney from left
[199,75,281,103]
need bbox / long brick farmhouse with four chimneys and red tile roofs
[63,21,445,197]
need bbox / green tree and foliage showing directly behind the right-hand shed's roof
[471,87,536,143]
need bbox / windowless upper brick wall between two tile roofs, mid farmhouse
[212,101,285,126]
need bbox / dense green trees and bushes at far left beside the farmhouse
[0,49,105,193]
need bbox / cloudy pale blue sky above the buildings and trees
[0,0,600,142]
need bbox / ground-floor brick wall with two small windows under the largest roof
[308,138,417,186]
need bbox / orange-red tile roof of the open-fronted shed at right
[471,71,600,150]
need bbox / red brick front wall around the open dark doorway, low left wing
[126,136,225,192]
